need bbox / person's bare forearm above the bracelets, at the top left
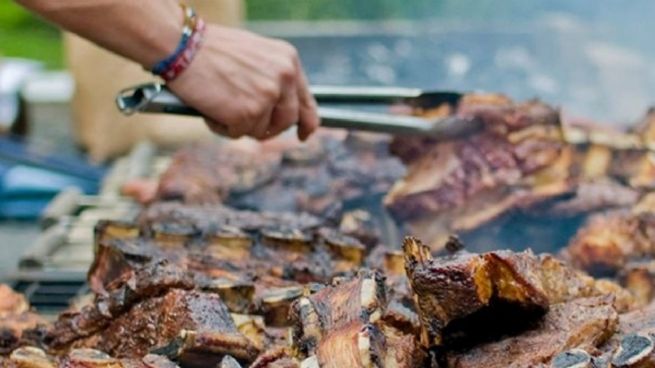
[17,0,183,68]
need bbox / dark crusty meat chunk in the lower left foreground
[47,288,258,366]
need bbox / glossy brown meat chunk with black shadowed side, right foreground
[404,238,631,347]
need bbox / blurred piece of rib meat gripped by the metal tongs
[384,95,572,247]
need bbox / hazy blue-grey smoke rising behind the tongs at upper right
[267,0,655,124]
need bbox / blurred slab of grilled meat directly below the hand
[158,137,404,221]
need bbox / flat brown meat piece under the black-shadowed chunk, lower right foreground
[447,296,619,368]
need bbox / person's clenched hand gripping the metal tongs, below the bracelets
[168,25,320,140]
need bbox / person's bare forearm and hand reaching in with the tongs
[18,0,319,139]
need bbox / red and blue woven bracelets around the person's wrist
[151,4,205,82]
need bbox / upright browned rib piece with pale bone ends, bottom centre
[291,271,423,367]
